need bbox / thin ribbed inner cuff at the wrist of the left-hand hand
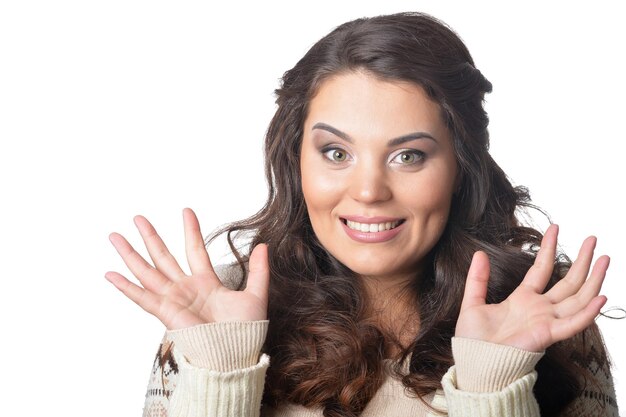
[167,320,269,372]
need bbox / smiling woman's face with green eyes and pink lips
[301,72,457,282]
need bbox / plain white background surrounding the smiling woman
[0,0,626,416]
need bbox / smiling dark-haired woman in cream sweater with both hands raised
[106,13,617,417]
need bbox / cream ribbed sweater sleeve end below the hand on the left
[144,321,269,417]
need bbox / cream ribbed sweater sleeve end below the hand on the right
[433,338,543,417]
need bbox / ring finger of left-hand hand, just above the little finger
[109,233,170,294]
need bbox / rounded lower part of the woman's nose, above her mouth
[350,164,391,204]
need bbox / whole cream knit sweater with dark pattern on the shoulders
[143,321,618,417]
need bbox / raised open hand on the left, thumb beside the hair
[105,208,269,330]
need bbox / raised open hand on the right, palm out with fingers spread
[455,225,609,352]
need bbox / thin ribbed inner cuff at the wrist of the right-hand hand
[452,337,544,392]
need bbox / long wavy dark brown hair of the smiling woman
[212,13,606,417]
